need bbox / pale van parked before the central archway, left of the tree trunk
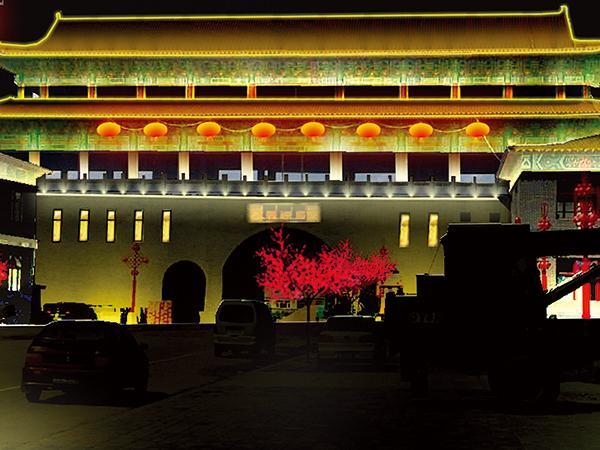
[214,300,275,356]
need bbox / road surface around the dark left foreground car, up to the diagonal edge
[0,328,302,450]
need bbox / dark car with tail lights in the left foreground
[21,320,148,402]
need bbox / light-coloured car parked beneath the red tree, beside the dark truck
[317,315,385,364]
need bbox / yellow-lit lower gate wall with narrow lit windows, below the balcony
[36,194,510,322]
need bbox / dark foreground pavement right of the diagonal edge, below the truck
[12,356,600,450]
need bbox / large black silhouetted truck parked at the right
[384,224,600,403]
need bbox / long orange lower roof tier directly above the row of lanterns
[0,98,600,119]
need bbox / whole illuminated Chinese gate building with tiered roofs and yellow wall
[0,7,600,321]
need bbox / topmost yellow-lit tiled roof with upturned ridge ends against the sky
[0,7,600,57]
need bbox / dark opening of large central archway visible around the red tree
[222,227,325,300]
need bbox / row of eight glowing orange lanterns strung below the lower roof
[96,121,491,139]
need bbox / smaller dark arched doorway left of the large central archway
[162,261,206,323]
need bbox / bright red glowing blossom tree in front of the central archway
[256,227,396,351]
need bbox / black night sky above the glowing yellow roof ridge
[0,0,600,96]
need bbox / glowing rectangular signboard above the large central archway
[247,203,321,223]
